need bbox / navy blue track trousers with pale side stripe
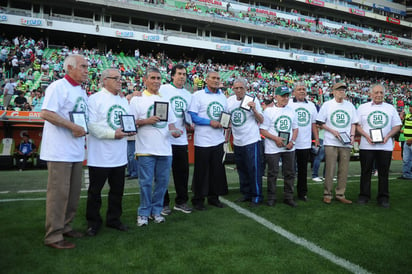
[234,142,263,203]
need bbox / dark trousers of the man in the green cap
[265,151,295,201]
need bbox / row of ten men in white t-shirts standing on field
[40,55,401,249]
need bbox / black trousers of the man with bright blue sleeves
[192,143,228,206]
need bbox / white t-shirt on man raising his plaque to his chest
[227,95,262,146]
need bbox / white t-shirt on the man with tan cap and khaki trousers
[316,99,359,147]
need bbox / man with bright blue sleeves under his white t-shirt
[189,71,228,210]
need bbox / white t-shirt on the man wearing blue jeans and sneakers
[130,91,176,156]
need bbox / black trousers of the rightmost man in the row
[359,149,392,203]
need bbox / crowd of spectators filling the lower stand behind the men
[0,36,412,114]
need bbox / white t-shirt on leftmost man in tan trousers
[40,78,88,162]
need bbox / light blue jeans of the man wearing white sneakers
[137,156,172,217]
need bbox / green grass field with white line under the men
[0,161,412,274]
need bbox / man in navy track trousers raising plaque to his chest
[227,78,263,207]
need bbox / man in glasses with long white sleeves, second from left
[86,69,136,236]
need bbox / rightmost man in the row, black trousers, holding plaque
[357,84,402,208]
